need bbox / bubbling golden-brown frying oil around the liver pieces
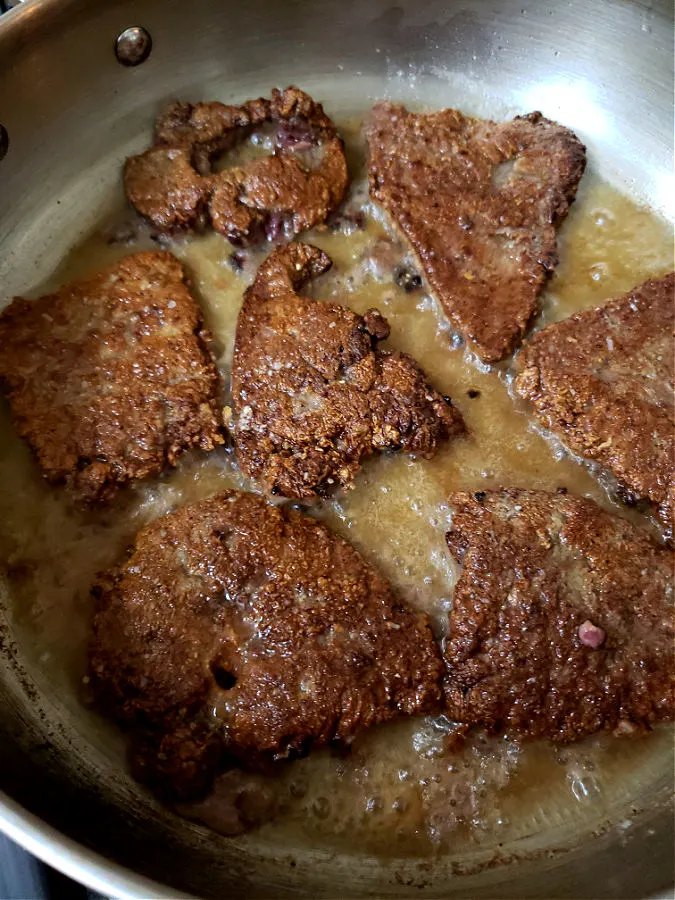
[0,118,672,855]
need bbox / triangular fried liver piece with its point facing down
[367,103,586,363]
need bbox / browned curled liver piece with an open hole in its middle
[124,87,349,244]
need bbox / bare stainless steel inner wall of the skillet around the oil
[0,0,675,897]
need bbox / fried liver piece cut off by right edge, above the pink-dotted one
[515,273,675,533]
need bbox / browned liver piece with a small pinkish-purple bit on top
[445,490,675,741]
